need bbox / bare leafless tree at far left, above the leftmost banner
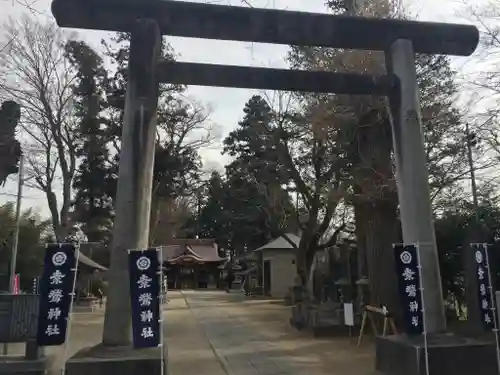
[0,16,77,237]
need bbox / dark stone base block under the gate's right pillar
[375,334,498,375]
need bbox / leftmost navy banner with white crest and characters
[37,244,76,346]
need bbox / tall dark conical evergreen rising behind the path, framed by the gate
[224,95,298,252]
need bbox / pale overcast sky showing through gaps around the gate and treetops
[0,0,481,216]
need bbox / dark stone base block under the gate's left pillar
[65,344,168,375]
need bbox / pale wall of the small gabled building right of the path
[263,250,297,298]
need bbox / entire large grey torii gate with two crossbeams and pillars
[52,0,484,375]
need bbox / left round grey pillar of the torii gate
[102,19,161,346]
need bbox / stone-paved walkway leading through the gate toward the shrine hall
[181,291,374,375]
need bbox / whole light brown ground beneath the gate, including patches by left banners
[9,291,374,375]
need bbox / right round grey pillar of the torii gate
[386,39,446,333]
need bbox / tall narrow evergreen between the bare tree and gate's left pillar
[66,41,116,242]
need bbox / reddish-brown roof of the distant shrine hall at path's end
[160,238,226,263]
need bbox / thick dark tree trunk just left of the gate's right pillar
[356,114,400,324]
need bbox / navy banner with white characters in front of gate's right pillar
[393,244,424,335]
